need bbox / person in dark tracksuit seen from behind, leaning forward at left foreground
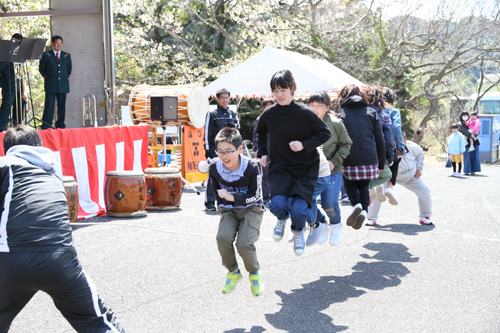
[0,125,124,333]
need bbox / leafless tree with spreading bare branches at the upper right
[376,1,500,142]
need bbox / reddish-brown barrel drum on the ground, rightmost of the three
[144,167,182,210]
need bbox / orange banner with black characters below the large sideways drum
[182,125,208,183]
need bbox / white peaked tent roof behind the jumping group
[205,46,363,98]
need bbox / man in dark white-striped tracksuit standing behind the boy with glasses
[203,88,240,211]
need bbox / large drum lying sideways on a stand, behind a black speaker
[128,84,209,128]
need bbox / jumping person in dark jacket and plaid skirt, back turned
[338,84,386,229]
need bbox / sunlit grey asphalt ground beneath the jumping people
[6,165,500,333]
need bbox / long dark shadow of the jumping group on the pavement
[266,243,419,332]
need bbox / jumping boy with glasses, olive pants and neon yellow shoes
[209,127,264,296]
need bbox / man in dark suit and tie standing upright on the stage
[39,36,71,129]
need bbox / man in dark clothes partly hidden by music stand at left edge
[0,34,23,132]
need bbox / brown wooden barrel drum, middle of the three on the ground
[104,171,147,217]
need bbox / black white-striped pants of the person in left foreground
[0,252,125,333]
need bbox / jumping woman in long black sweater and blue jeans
[257,70,331,255]
